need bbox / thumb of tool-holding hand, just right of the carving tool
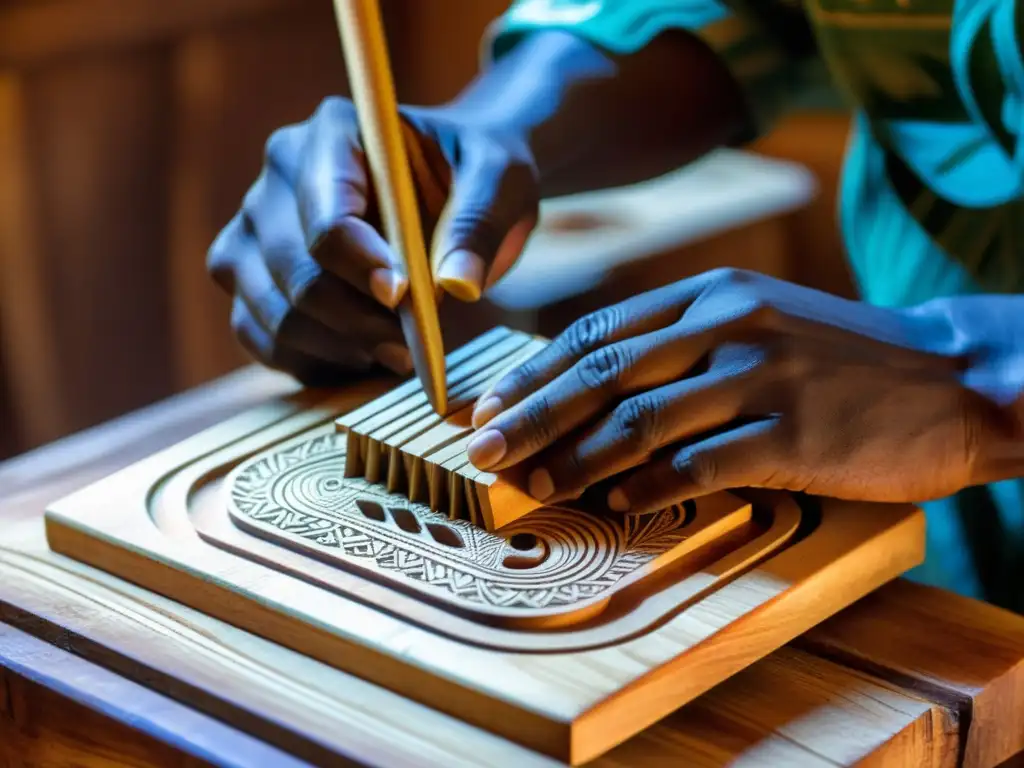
[431,145,540,301]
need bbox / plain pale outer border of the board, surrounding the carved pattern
[41,360,923,764]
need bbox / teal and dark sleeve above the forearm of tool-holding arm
[482,0,819,140]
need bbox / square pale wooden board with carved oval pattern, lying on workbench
[46,331,924,763]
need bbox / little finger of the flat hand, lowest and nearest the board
[607,419,782,514]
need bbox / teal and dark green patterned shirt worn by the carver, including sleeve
[484,0,1024,611]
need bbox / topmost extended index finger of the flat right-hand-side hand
[473,286,681,428]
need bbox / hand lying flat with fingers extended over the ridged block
[469,269,990,512]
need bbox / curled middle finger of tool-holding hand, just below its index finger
[245,168,402,354]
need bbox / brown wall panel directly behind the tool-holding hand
[169,3,345,388]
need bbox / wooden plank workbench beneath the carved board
[0,369,1024,768]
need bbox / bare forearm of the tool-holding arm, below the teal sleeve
[421,32,749,197]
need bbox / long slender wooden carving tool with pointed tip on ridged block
[334,0,447,416]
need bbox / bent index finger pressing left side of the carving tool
[294,99,408,309]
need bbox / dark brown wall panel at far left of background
[26,49,176,438]
